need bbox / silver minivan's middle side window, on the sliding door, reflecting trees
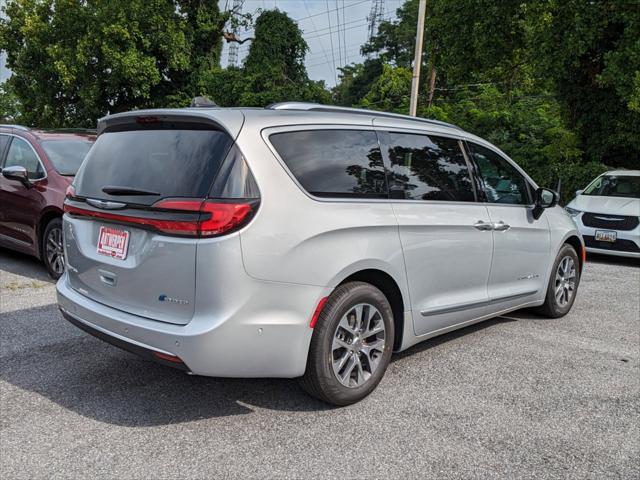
[386,132,475,202]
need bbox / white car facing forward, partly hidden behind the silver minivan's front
[566,170,640,258]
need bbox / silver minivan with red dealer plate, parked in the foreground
[57,103,584,405]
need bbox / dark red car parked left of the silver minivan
[0,125,95,279]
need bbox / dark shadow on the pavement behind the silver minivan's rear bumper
[0,305,331,427]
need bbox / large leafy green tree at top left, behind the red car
[0,0,228,126]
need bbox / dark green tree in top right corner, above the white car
[529,0,640,168]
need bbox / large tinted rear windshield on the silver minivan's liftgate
[74,129,233,205]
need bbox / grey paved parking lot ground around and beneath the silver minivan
[0,250,640,479]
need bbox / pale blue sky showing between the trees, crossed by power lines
[219,0,404,86]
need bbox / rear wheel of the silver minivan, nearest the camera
[300,282,394,406]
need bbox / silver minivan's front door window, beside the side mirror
[469,143,531,205]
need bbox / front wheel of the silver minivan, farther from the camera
[536,244,580,318]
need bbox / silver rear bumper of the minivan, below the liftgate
[56,274,325,378]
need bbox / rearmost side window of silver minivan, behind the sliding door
[269,130,387,198]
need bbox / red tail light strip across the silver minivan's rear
[64,200,255,237]
